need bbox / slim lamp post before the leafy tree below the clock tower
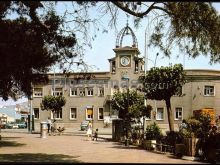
[122,75,130,146]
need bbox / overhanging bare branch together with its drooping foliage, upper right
[113,1,220,63]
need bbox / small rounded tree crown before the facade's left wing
[41,95,66,112]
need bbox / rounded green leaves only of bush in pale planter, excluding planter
[145,122,162,140]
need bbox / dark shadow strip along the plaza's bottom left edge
[0,153,83,164]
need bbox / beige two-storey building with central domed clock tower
[31,25,220,133]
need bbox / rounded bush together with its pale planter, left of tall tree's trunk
[144,122,162,150]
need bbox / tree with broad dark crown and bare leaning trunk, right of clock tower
[140,64,186,131]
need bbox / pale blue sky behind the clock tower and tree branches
[0,1,220,105]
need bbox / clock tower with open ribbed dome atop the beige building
[109,23,144,79]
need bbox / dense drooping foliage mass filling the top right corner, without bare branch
[164,2,220,62]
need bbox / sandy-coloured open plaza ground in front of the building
[0,131,208,164]
